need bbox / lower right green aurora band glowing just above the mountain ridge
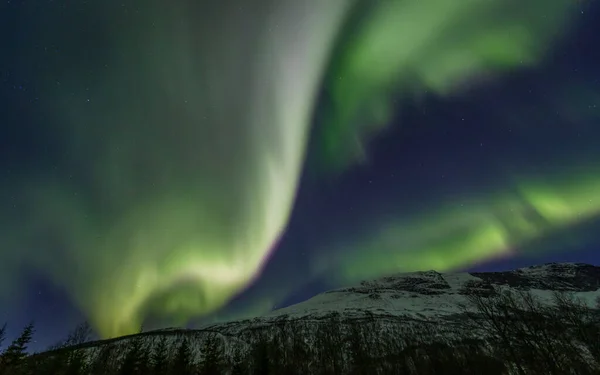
[314,167,600,283]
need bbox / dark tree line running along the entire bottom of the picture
[0,292,600,375]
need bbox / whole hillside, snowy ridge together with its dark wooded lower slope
[4,263,600,374]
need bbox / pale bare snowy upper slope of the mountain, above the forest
[207,263,600,335]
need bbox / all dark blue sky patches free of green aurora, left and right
[0,1,600,348]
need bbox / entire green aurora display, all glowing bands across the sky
[0,0,600,337]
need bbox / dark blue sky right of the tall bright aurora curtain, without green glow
[256,3,600,324]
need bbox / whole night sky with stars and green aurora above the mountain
[0,0,600,350]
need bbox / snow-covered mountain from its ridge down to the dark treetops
[38,263,600,374]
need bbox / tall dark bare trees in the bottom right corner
[460,291,600,375]
